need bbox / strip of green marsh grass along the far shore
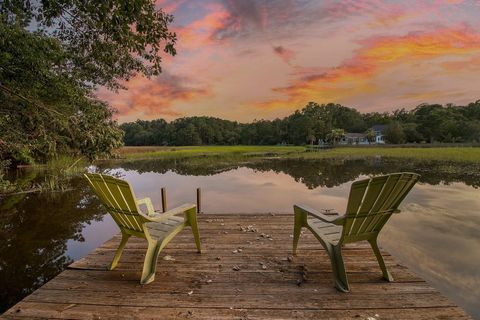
[119,146,480,162]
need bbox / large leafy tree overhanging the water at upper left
[0,0,176,162]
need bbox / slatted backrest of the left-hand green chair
[85,173,146,232]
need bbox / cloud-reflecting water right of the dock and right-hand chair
[380,183,480,318]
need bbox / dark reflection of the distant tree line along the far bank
[107,157,480,189]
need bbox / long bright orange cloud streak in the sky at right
[257,29,480,108]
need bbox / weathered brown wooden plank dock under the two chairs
[2,214,470,320]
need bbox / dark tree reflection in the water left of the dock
[0,179,103,312]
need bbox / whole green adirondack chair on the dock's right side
[293,173,420,292]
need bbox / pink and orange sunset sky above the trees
[98,0,480,122]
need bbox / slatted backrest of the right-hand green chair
[341,173,420,243]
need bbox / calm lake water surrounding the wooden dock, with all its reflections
[0,158,480,319]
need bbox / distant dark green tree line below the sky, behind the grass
[120,100,480,146]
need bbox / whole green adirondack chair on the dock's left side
[85,173,201,284]
